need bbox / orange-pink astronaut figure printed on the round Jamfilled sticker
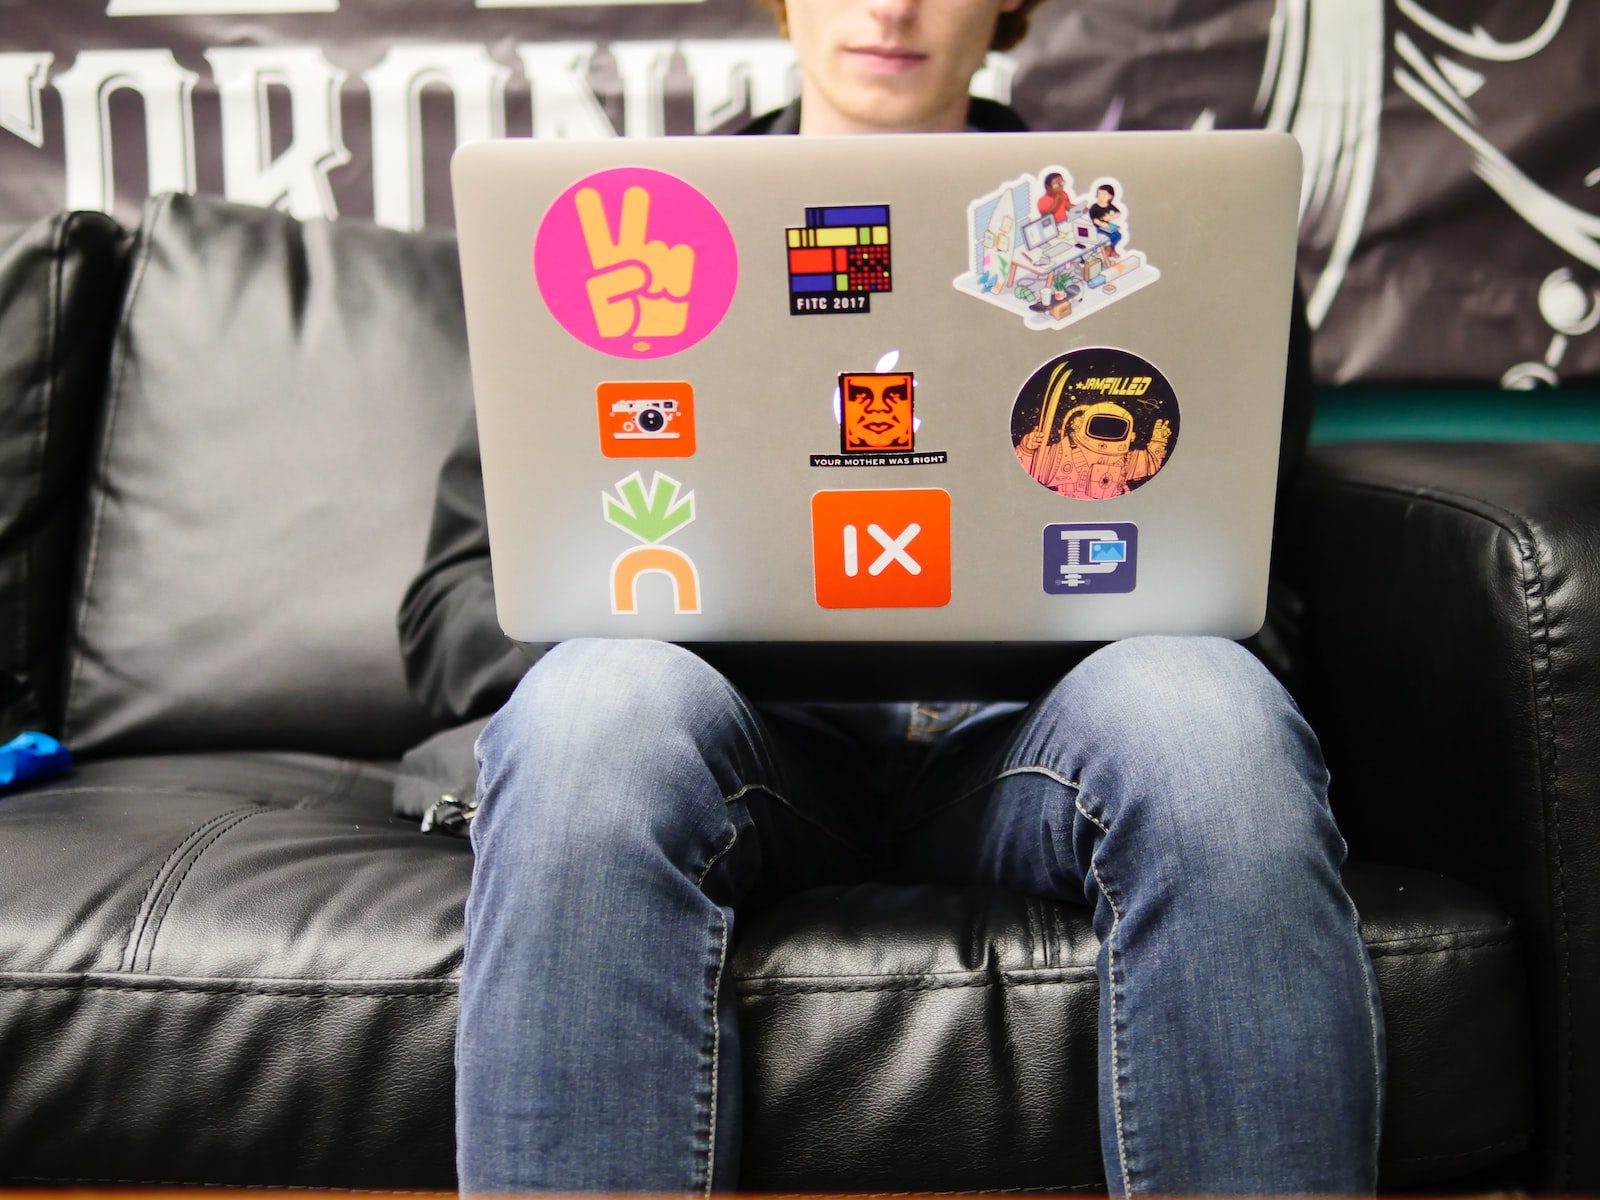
[1016,400,1173,499]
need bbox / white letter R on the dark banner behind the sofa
[205,46,350,221]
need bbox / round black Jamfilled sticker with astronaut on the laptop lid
[1011,346,1178,499]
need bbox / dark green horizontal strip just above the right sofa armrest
[1310,384,1600,445]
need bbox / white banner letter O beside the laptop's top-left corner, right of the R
[362,45,510,230]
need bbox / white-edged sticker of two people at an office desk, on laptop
[954,166,1162,330]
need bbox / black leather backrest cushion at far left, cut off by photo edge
[0,213,126,741]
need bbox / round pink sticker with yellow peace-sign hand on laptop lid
[533,166,739,358]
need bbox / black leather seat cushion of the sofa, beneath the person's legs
[0,754,1533,1192]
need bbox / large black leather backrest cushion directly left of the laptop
[64,197,472,757]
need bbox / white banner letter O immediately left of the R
[51,50,200,213]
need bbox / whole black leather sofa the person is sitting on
[0,198,1600,1190]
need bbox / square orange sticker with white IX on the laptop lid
[811,488,950,608]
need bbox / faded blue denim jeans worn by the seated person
[456,638,1384,1195]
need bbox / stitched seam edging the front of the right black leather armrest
[1331,478,1576,1190]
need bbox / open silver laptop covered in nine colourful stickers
[454,133,1301,668]
